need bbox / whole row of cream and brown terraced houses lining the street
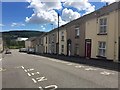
[26,2,120,62]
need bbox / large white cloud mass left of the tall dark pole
[25,0,62,24]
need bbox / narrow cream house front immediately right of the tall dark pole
[59,26,67,55]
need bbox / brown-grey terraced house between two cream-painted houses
[66,17,85,57]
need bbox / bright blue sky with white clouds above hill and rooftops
[0,0,115,32]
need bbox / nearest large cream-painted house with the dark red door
[85,2,120,62]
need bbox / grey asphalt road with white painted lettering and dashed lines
[0,50,118,90]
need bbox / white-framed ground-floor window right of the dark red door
[98,42,106,57]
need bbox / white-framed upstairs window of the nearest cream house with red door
[99,18,107,34]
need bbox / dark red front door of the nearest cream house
[85,39,91,58]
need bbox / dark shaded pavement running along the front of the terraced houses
[34,54,120,71]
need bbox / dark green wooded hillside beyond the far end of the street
[2,30,44,48]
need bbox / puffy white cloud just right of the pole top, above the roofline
[62,8,80,21]
